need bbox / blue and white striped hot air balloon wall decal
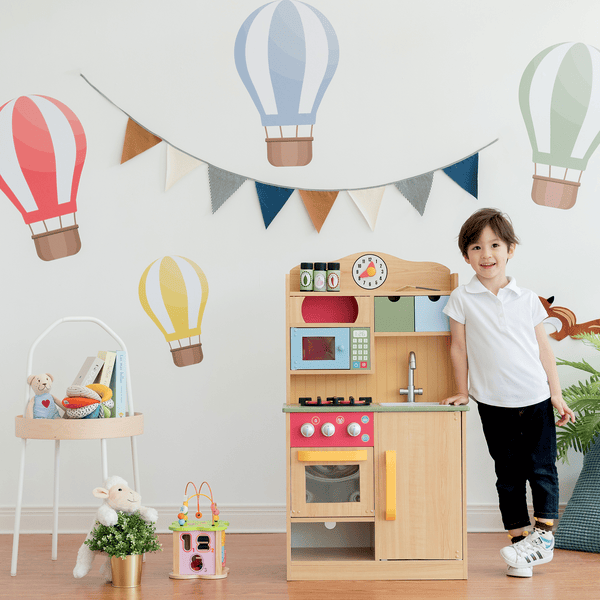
[234,0,339,167]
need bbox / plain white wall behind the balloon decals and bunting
[0,0,600,531]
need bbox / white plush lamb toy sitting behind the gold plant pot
[73,476,158,581]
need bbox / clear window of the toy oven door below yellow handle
[304,464,360,504]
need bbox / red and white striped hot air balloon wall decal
[0,95,87,260]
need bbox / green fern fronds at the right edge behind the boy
[556,333,600,463]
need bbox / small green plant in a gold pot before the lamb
[84,512,162,587]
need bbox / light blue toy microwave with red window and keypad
[290,327,371,371]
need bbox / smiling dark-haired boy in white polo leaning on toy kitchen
[441,208,575,577]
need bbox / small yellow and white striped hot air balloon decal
[139,256,208,367]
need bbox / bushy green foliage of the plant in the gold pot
[84,512,162,558]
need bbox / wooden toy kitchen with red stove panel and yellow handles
[283,253,468,580]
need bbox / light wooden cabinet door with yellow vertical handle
[375,412,464,560]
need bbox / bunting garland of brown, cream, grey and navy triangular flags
[81,74,498,232]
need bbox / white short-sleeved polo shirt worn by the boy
[444,275,550,408]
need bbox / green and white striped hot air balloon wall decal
[519,42,600,209]
